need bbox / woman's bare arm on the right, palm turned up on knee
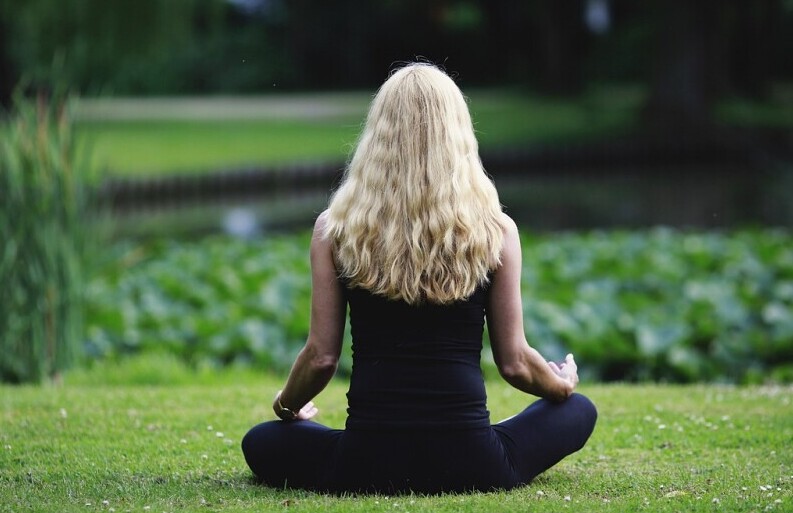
[486,215,578,401]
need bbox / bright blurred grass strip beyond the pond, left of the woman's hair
[78,120,359,176]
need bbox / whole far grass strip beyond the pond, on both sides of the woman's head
[44,84,793,176]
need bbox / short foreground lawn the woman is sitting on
[0,362,793,512]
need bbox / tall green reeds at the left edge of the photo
[0,92,94,382]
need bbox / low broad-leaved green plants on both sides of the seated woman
[82,228,793,382]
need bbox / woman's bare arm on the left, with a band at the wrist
[273,211,347,420]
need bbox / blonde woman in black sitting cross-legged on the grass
[242,64,597,493]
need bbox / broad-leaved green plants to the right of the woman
[523,229,793,381]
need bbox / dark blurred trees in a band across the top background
[0,0,793,99]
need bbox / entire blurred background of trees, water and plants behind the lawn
[0,0,793,382]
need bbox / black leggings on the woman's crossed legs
[242,394,597,494]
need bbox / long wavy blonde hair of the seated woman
[325,64,504,304]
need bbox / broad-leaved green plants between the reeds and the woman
[87,235,311,370]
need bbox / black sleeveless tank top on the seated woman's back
[345,286,490,429]
